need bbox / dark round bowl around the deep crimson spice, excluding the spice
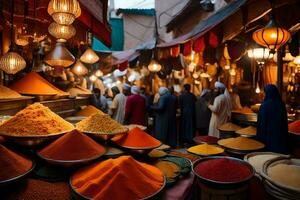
[192,156,255,189]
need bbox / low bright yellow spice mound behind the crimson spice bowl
[187,144,224,156]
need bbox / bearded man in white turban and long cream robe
[208,81,232,138]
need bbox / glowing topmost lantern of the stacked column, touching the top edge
[48,0,81,25]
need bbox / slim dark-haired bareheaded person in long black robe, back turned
[179,84,196,143]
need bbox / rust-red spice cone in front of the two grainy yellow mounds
[39,130,105,161]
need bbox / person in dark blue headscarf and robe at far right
[257,84,288,153]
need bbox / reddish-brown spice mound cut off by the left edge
[0,144,32,181]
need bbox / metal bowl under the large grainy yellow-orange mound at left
[0,132,66,147]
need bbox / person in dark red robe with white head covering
[125,86,146,126]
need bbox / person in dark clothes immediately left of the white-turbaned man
[195,89,211,135]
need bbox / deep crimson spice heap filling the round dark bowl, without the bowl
[194,158,253,183]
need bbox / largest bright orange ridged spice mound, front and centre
[70,156,164,200]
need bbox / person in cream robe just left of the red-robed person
[110,86,126,124]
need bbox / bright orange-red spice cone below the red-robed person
[112,127,161,149]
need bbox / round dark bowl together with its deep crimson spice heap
[193,156,255,189]
